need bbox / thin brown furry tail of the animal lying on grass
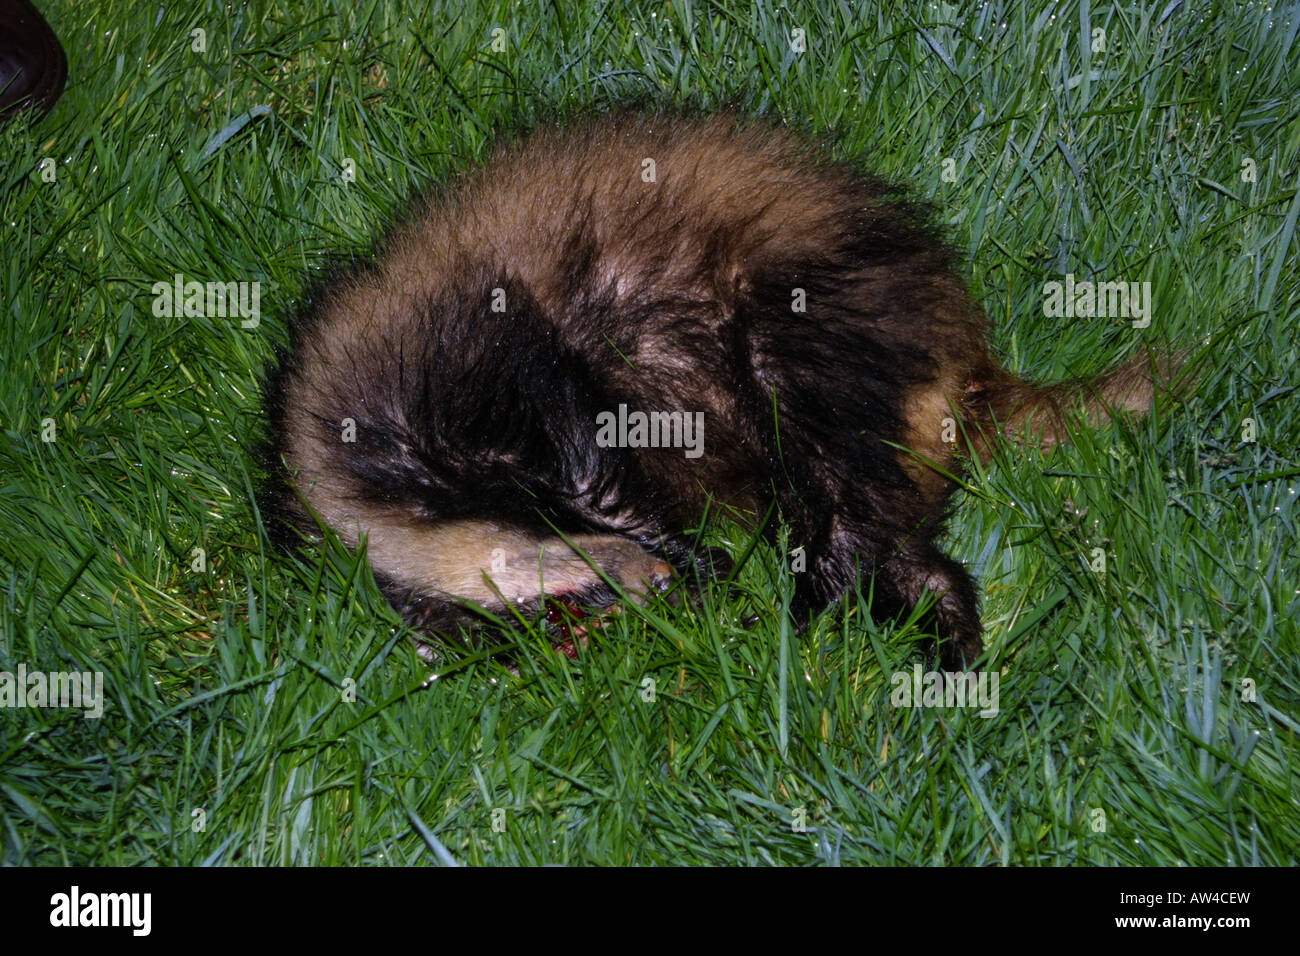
[963,349,1192,460]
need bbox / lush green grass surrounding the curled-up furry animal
[0,0,1300,865]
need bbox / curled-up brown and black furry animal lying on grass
[263,112,1180,667]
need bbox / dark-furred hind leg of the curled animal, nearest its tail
[742,281,982,667]
